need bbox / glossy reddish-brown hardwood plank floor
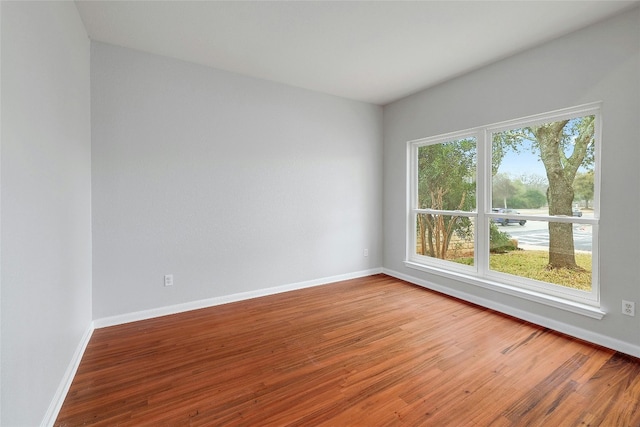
[56,275,640,427]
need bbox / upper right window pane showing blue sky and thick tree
[491,115,595,217]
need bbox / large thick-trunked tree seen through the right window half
[494,116,595,269]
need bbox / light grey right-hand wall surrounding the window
[383,8,640,355]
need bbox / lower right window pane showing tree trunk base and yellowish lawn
[489,219,593,291]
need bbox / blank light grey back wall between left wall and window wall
[91,43,382,319]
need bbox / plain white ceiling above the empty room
[76,0,638,105]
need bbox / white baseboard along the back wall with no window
[93,268,382,329]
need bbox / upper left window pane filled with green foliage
[417,137,476,212]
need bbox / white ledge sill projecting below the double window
[404,261,606,320]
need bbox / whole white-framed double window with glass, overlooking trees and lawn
[406,104,601,317]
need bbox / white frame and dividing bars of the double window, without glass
[405,103,605,319]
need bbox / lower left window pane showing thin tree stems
[416,214,474,265]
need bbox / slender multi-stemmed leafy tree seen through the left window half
[417,139,476,259]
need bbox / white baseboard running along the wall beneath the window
[382,268,640,357]
